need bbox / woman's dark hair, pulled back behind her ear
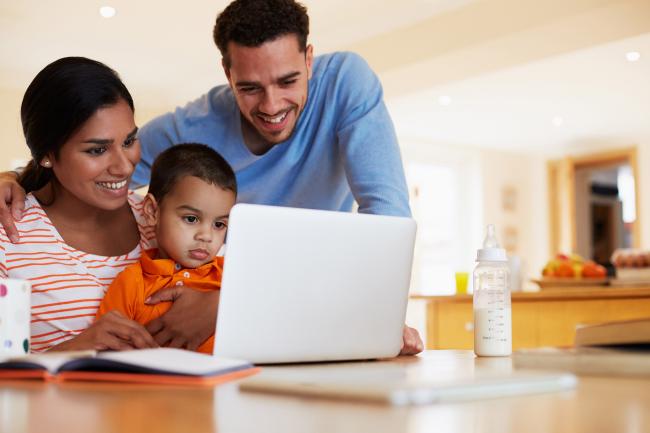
[18,57,133,192]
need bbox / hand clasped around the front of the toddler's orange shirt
[145,286,219,350]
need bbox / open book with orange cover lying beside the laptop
[0,348,259,385]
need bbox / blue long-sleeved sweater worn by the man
[133,53,410,216]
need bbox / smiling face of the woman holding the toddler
[47,99,140,210]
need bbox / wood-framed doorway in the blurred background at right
[548,148,641,266]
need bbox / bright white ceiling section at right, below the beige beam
[390,34,650,154]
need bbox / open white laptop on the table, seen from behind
[214,204,416,364]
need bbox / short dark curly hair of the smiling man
[213,0,309,68]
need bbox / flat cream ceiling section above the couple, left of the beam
[0,0,468,111]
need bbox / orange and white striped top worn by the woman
[0,191,155,352]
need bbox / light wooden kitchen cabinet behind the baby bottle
[411,286,650,349]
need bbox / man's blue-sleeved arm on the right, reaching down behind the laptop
[336,53,411,216]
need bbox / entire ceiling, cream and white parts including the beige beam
[0,0,650,154]
